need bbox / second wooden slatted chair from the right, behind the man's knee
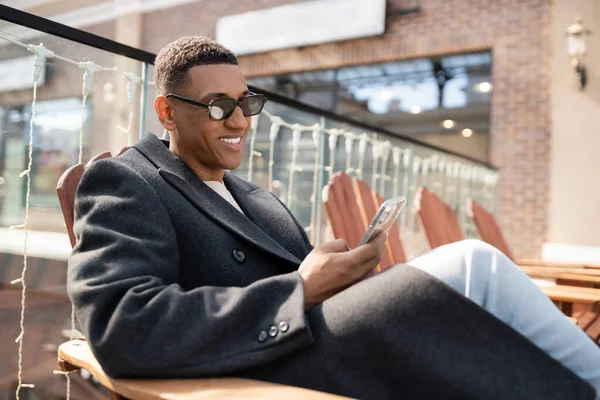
[414,187,600,324]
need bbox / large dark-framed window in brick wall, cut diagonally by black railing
[248,52,493,161]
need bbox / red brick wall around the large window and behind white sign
[143,0,553,257]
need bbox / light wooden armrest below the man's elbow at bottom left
[58,340,347,400]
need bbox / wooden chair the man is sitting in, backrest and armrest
[56,148,346,400]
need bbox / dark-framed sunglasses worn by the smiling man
[165,93,267,121]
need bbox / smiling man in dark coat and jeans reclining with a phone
[68,37,600,399]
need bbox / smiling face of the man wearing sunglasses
[163,64,252,180]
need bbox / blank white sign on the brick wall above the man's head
[216,0,386,55]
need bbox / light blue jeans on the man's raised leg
[408,240,600,398]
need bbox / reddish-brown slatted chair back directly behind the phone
[323,172,406,271]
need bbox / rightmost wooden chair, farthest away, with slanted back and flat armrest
[466,197,600,272]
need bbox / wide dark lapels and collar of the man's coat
[133,135,302,264]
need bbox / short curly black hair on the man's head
[154,36,238,94]
